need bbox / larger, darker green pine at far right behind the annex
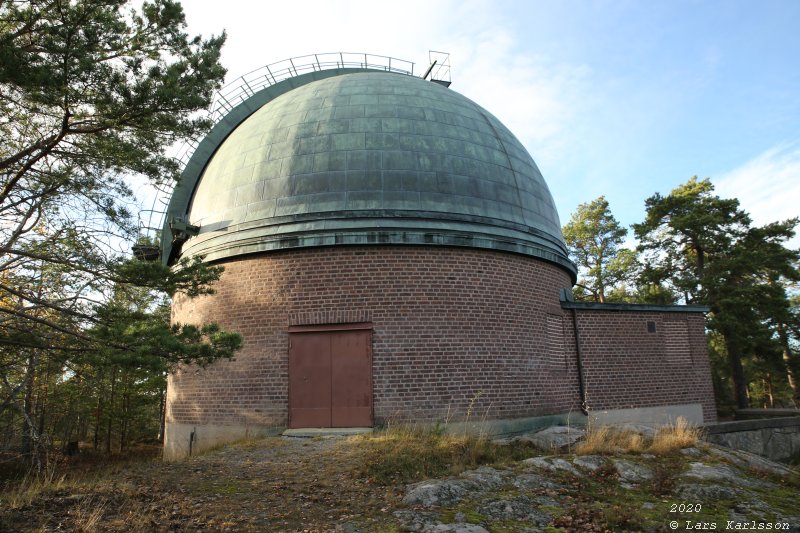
[634,178,800,407]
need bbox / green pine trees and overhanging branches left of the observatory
[0,0,241,462]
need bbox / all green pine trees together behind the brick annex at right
[563,177,800,409]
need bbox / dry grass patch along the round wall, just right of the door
[350,426,535,485]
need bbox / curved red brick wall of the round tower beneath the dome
[167,246,578,426]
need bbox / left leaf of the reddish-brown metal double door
[289,332,331,428]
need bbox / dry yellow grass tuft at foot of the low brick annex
[575,417,701,455]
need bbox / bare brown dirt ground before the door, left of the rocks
[0,437,402,532]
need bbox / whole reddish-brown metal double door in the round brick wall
[289,326,372,428]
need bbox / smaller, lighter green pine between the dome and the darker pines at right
[563,196,636,302]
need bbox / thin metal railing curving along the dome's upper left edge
[134,52,414,255]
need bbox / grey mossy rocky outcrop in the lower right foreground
[395,432,800,533]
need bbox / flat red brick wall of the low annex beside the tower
[567,310,717,422]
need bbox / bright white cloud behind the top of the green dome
[184,0,591,172]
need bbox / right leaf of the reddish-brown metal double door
[330,330,372,427]
